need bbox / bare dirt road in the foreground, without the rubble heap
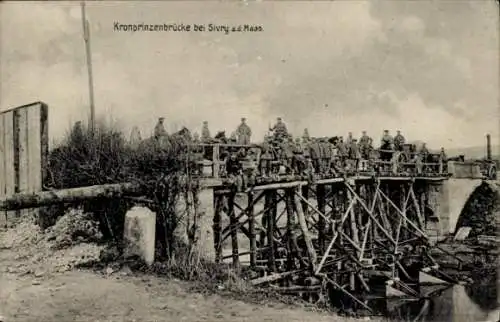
[0,226,376,322]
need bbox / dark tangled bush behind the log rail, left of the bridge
[45,122,198,258]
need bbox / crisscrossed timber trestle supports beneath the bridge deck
[213,178,454,310]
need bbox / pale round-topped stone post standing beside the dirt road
[123,207,156,265]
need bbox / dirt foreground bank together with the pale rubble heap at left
[0,218,379,322]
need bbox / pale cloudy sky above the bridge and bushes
[0,0,500,147]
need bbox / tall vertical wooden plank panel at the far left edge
[0,102,49,224]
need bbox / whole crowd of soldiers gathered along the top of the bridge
[149,118,446,184]
